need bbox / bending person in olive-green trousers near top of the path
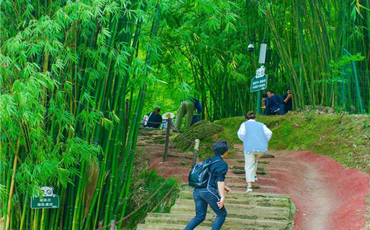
[175,97,202,131]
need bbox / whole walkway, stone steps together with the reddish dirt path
[138,130,370,230]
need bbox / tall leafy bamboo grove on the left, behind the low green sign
[0,0,161,229]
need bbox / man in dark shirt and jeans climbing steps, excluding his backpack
[185,141,231,230]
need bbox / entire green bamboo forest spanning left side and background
[0,0,370,230]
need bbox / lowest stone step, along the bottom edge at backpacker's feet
[145,213,290,230]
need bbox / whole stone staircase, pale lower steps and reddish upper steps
[137,131,294,230]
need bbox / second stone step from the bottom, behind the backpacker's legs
[171,199,290,220]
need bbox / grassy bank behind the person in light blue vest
[215,113,370,173]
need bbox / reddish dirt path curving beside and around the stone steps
[145,145,370,230]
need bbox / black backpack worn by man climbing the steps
[188,158,220,188]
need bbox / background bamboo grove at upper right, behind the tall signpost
[146,0,370,120]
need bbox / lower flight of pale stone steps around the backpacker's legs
[137,186,292,230]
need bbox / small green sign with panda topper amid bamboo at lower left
[31,186,59,209]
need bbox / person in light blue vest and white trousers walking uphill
[237,112,272,192]
